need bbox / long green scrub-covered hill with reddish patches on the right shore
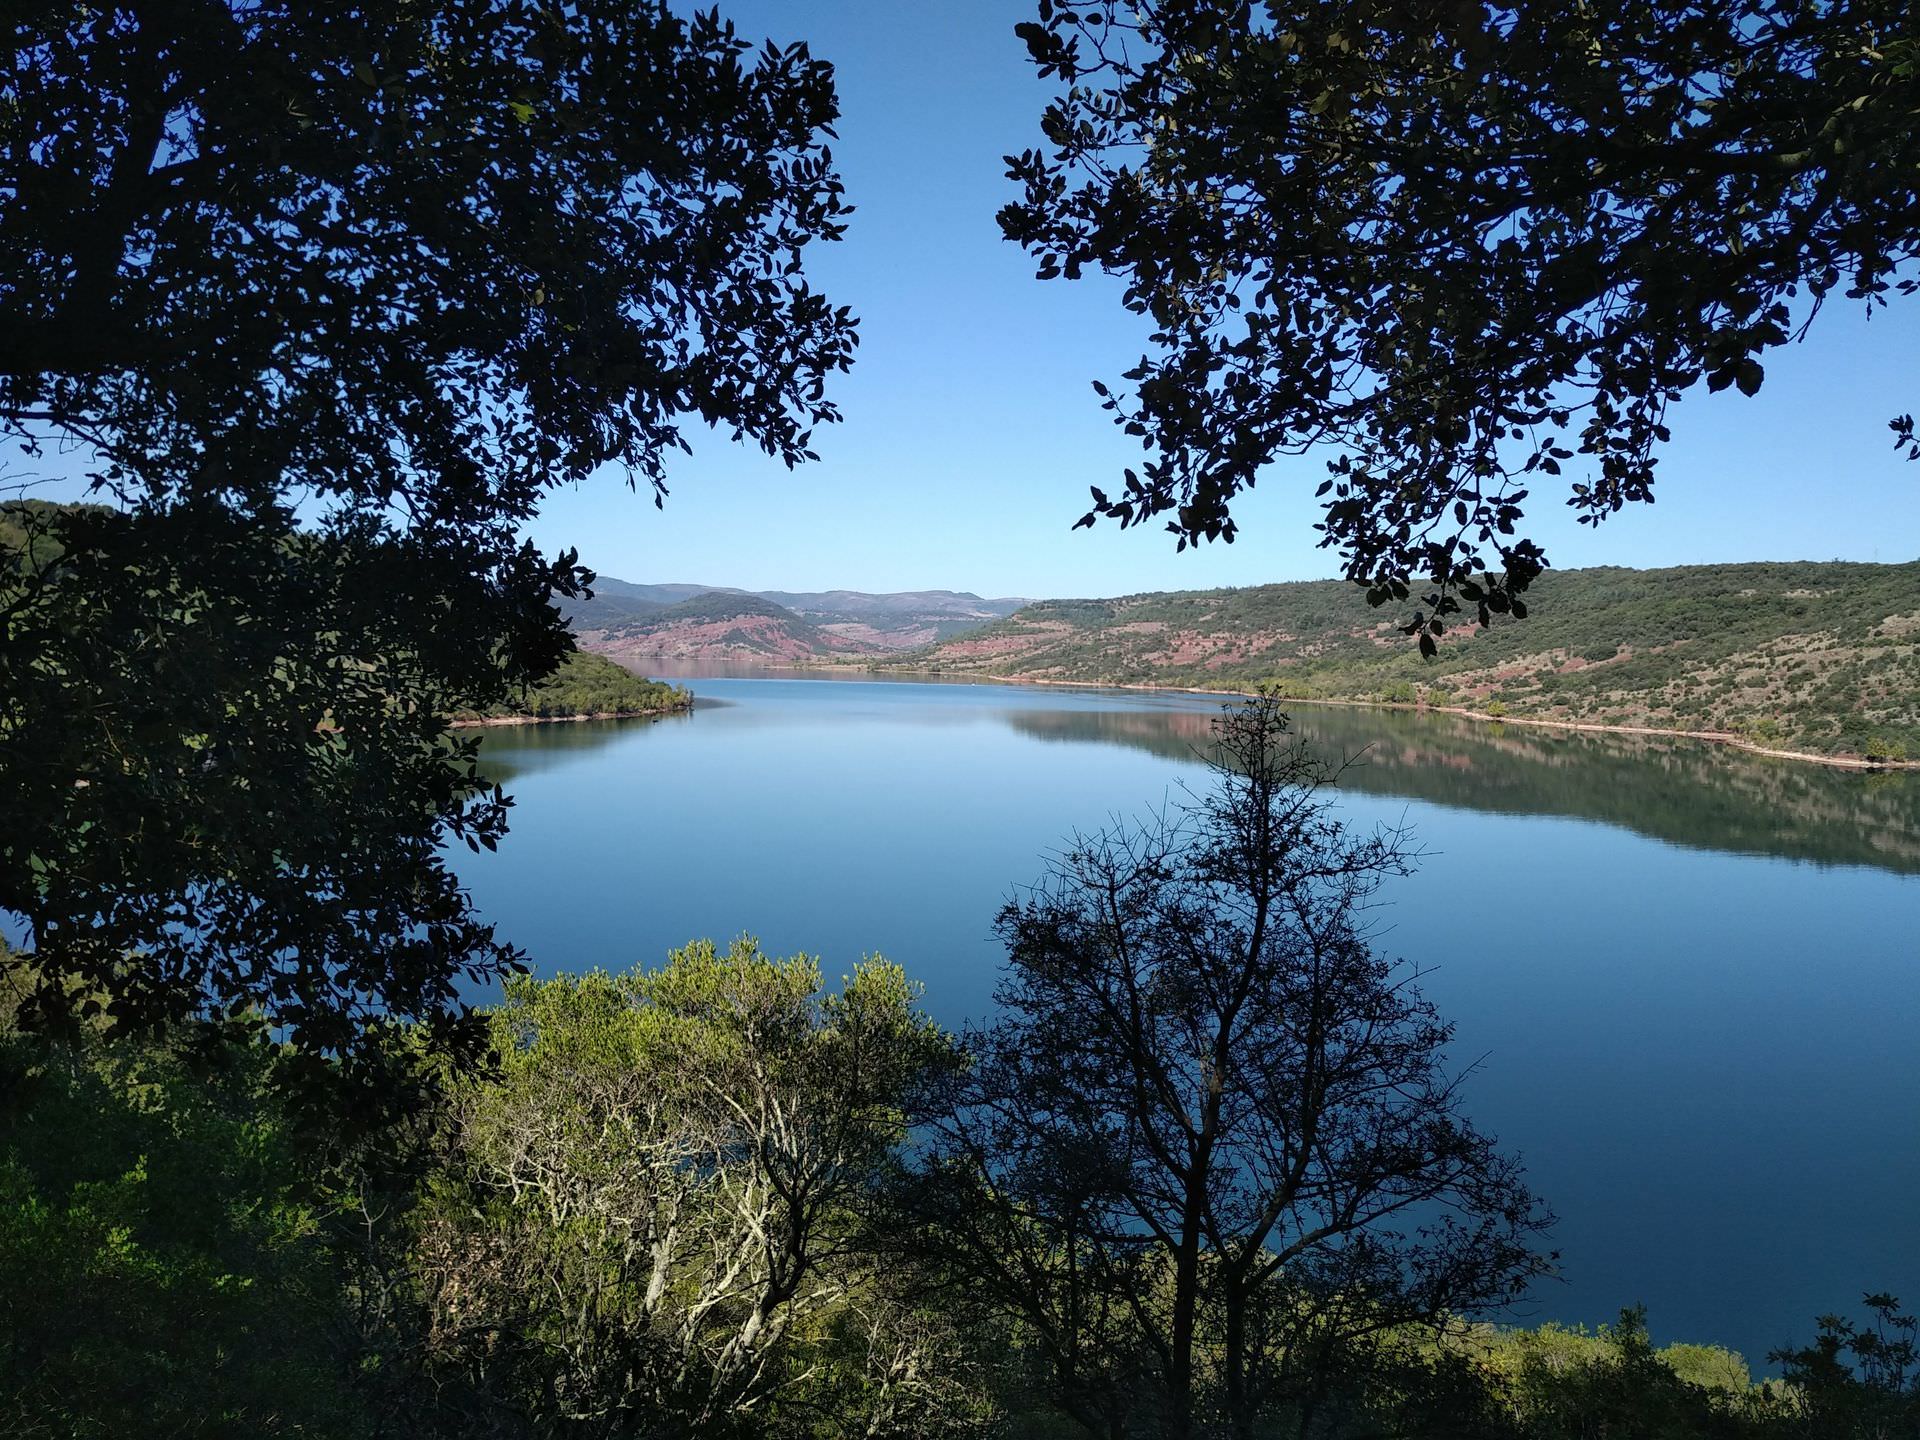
[897,561,1920,758]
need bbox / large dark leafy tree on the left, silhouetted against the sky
[0,0,854,1075]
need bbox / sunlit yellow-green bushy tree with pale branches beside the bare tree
[417,941,964,1436]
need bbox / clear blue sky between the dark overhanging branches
[18,0,1920,597]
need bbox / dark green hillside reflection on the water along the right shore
[1008,705,1920,874]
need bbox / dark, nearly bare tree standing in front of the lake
[918,701,1544,1436]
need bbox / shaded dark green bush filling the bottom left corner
[0,1006,376,1440]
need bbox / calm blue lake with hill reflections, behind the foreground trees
[457,674,1920,1371]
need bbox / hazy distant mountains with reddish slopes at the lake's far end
[568,576,1027,664]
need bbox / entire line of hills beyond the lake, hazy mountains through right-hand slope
[574,561,1920,760]
